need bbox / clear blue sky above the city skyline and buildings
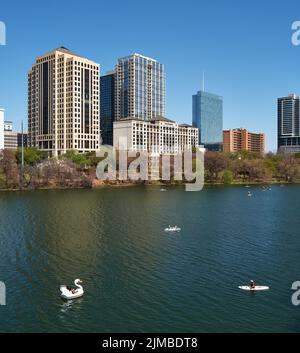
[0,0,300,150]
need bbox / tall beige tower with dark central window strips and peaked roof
[28,47,100,156]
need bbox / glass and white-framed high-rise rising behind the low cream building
[116,54,166,121]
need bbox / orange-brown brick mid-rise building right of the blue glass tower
[223,129,265,154]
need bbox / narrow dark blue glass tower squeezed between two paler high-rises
[100,71,115,146]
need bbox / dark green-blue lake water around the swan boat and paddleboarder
[0,186,300,332]
